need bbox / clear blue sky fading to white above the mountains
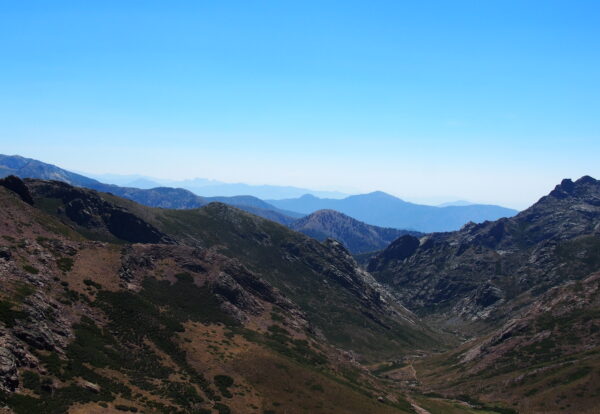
[0,0,600,207]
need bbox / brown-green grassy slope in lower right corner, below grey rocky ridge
[416,273,600,413]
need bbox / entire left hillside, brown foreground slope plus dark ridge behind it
[0,178,464,414]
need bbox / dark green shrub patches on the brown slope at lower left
[11,277,241,414]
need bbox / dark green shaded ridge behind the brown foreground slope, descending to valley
[25,180,446,357]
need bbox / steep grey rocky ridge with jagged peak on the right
[368,177,600,329]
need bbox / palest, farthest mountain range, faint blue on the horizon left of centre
[83,173,348,199]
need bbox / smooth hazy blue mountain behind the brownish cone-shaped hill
[267,191,517,233]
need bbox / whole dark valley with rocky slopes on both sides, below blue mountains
[0,172,600,414]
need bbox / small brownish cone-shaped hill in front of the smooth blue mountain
[289,210,419,254]
